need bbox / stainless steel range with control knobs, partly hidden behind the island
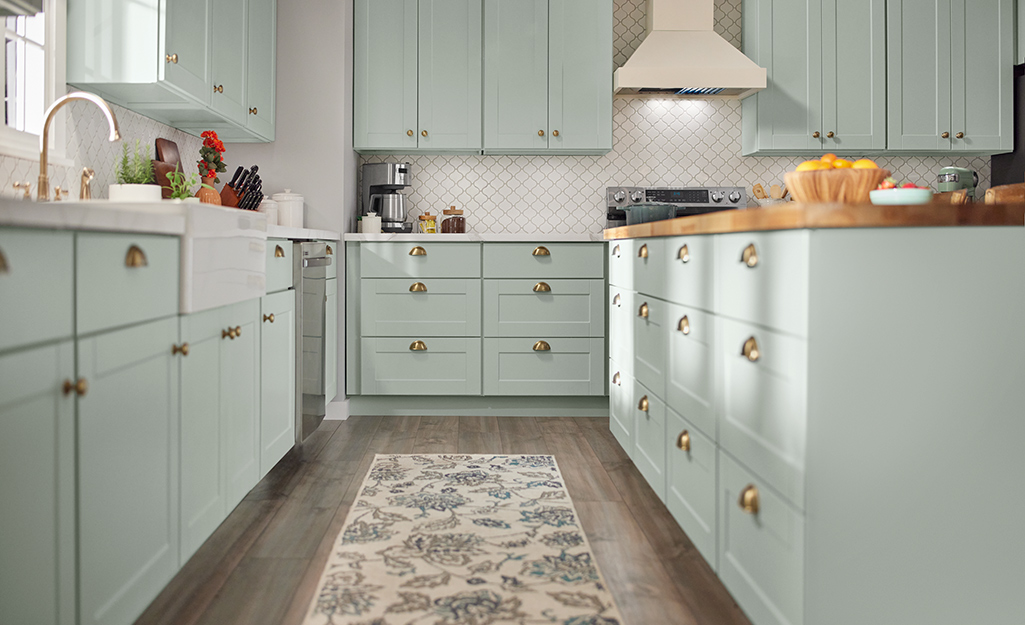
[605,186,747,227]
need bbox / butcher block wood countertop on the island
[605,203,1025,239]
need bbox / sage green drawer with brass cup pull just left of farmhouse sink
[76,233,180,334]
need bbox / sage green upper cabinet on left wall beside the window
[68,0,277,141]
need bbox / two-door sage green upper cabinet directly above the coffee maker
[354,0,482,154]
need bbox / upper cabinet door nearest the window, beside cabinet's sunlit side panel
[164,0,213,105]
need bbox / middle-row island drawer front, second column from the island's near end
[665,304,718,440]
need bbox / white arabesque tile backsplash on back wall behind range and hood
[360,0,990,234]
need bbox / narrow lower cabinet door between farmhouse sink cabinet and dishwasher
[259,291,295,469]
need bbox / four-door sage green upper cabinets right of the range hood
[743,0,1015,156]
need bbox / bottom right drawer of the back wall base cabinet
[484,336,605,395]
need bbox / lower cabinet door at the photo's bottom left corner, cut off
[0,341,75,625]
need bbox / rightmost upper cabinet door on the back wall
[950,0,1015,153]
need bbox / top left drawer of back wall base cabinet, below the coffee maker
[360,241,481,278]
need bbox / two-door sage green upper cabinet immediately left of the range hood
[484,0,613,154]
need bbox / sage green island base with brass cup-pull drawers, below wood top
[606,226,1025,625]
